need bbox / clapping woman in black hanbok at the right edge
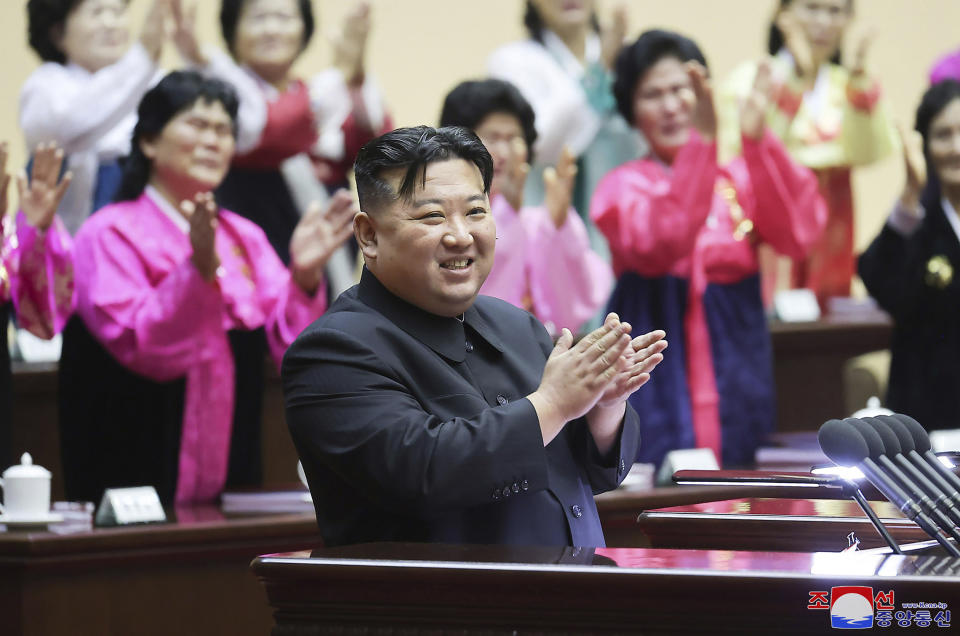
[859,79,960,429]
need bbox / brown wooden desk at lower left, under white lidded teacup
[0,507,321,636]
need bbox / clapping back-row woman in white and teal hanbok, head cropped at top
[487,0,645,258]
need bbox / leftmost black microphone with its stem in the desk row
[817,420,960,556]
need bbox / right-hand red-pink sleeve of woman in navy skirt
[742,130,827,258]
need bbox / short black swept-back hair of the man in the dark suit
[353,126,493,214]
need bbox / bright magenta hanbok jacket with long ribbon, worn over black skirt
[75,186,326,503]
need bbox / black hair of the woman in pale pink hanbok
[440,79,537,162]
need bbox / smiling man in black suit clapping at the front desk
[282,126,666,546]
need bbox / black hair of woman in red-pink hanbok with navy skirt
[613,29,707,125]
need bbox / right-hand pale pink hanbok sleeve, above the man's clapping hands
[520,206,613,333]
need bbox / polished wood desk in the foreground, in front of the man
[251,544,960,636]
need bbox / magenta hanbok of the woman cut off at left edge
[0,212,73,466]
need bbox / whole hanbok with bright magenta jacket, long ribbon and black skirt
[64,186,326,503]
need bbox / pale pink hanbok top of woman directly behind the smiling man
[480,194,613,335]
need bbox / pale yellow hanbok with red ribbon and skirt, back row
[719,51,897,309]
